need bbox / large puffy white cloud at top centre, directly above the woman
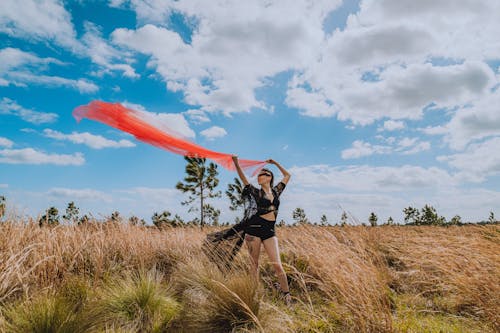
[112,1,340,114]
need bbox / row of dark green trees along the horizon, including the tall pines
[0,157,499,228]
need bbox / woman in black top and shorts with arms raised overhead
[233,156,291,304]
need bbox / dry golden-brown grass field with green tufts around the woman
[0,221,500,332]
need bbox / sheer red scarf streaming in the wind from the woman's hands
[73,101,266,176]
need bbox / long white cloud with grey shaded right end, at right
[289,62,496,125]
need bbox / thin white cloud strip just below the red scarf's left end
[43,128,135,149]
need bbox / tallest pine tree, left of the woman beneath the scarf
[176,156,221,228]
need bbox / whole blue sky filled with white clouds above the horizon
[0,0,500,223]
